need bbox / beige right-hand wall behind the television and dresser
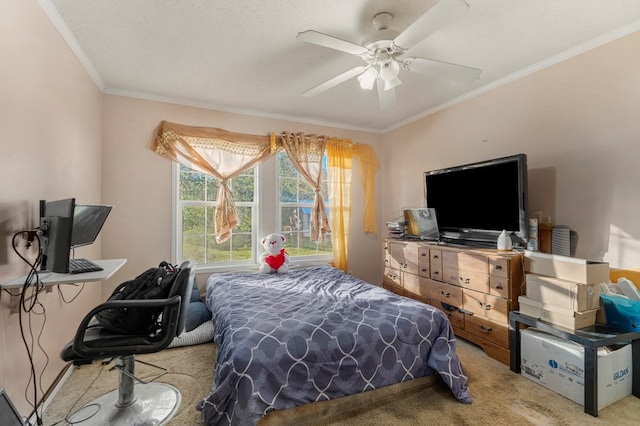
[380,32,640,268]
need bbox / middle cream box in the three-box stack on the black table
[525,273,600,311]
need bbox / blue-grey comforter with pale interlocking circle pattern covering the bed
[198,266,471,425]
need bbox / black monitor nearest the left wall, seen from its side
[40,198,76,274]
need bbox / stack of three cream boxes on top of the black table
[518,252,609,330]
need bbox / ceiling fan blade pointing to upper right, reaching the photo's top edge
[393,0,469,49]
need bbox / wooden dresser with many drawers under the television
[382,239,525,365]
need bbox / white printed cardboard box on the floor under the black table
[520,328,633,409]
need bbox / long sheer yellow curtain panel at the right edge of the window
[326,138,353,272]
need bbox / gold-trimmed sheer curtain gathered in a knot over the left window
[151,121,273,243]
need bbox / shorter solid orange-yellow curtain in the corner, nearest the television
[353,143,380,234]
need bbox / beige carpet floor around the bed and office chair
[43,339,640,426]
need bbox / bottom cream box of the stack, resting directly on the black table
[518,296,598,330]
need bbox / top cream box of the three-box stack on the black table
[524,250,609,284]
